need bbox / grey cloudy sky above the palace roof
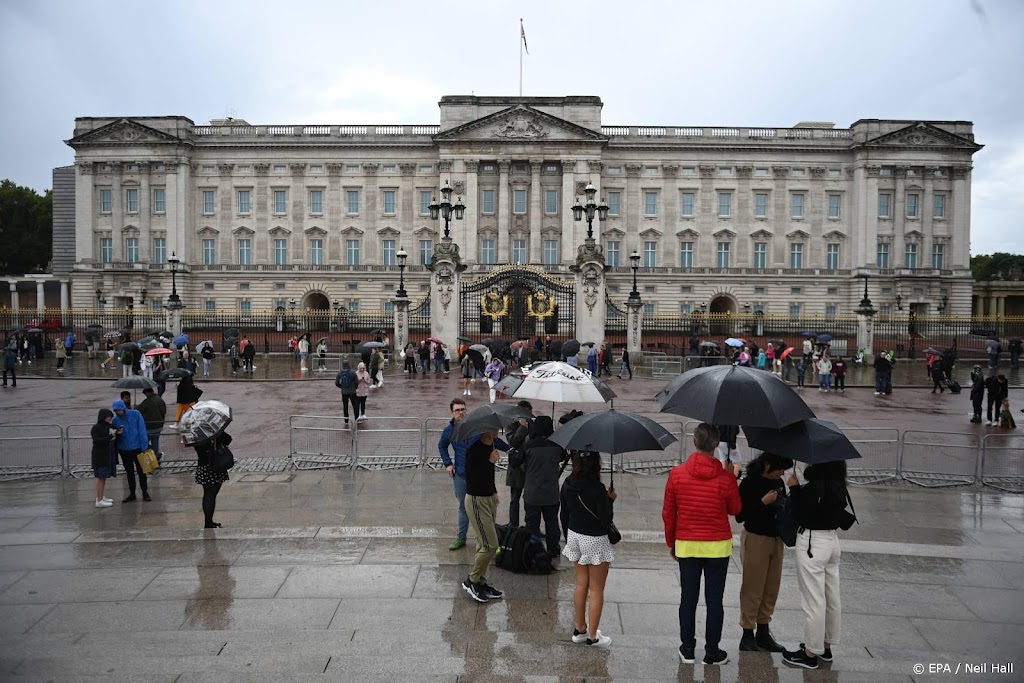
[0,0,1024,254]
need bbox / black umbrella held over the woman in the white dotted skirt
[550,409,678,486]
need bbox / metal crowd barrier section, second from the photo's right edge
[899,430,981,488]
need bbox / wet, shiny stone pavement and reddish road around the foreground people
[0,370,1024,683]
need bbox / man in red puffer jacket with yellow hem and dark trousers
[662,423,742,665]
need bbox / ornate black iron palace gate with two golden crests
[459,265,575,341]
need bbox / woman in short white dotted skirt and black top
[561,453,615,647]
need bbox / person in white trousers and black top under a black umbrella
[782,461,856,669]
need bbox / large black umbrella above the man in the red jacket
[657,366,814,429]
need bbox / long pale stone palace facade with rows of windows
[54,96,981,314]
